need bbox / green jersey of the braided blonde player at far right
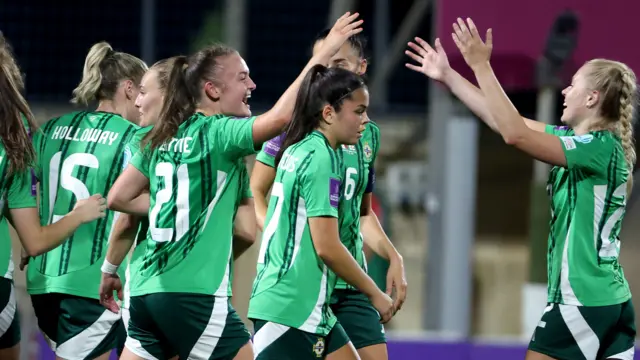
[546,125,631,306]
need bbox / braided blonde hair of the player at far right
[586,59,638,192]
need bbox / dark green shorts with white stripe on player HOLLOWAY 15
[31,293,126,360]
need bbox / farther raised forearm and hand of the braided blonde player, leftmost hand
[405,37,545,132]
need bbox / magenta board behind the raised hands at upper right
[436,0,640,90]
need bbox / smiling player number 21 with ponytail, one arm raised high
[108,14,362,359]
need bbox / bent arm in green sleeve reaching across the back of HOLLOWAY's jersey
[7,170,106,256]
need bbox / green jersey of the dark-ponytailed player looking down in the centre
[248,131,343,336]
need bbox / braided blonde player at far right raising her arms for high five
[410,19,636,360]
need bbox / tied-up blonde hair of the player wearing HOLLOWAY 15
[71,41,147,105]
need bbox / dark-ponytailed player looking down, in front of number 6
[248,65,394,360]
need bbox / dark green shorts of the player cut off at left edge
[0,278,20,349]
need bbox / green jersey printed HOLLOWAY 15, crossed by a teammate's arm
[27,111,139,299]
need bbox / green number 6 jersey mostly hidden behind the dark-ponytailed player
[256,122,380,289]
